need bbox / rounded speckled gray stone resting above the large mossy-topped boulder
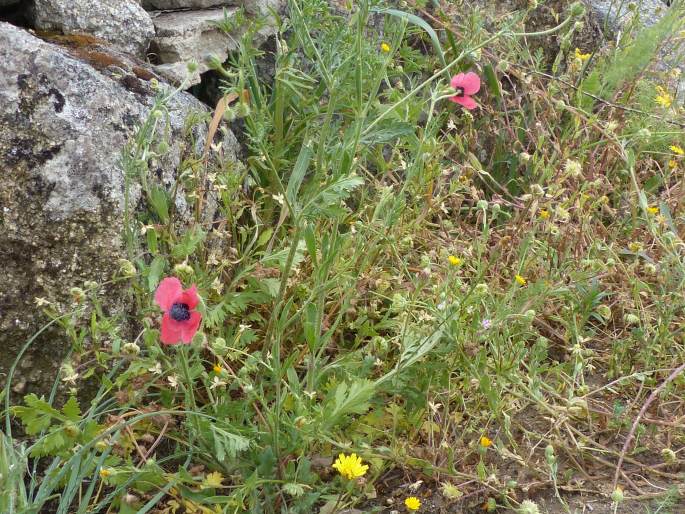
[30,0,154,57]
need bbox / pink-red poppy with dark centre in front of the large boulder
[155,277,202,344]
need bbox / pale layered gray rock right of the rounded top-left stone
[150,7,274,87]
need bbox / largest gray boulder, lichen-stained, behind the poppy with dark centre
[0,23,236,393]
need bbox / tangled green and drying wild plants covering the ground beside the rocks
[5,0,685,508]
